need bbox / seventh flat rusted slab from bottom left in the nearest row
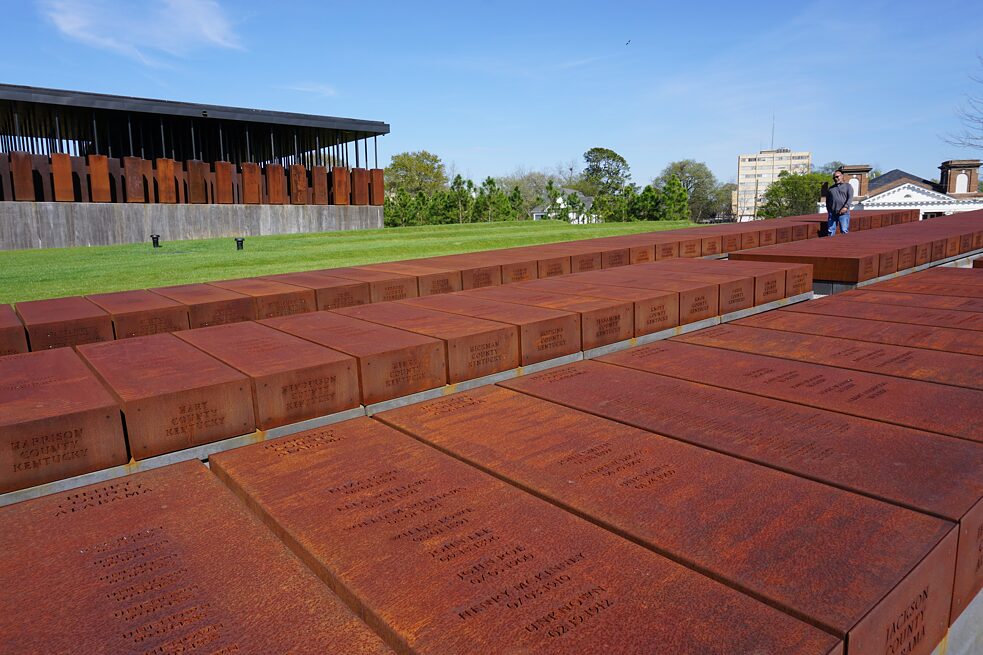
[731,311,983,356]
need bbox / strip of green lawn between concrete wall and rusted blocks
[0,221,687,303]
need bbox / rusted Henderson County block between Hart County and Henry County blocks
[179,322,359,430]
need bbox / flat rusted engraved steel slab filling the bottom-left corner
[0,462,390,655]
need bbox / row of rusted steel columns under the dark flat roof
[0,152,385,205]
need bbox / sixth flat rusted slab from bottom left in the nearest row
[674,324,983,390]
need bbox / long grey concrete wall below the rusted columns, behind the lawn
[0,202,382,250]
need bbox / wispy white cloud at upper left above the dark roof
[38,0,242,67]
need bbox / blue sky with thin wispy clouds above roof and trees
[0,0,983,185]
